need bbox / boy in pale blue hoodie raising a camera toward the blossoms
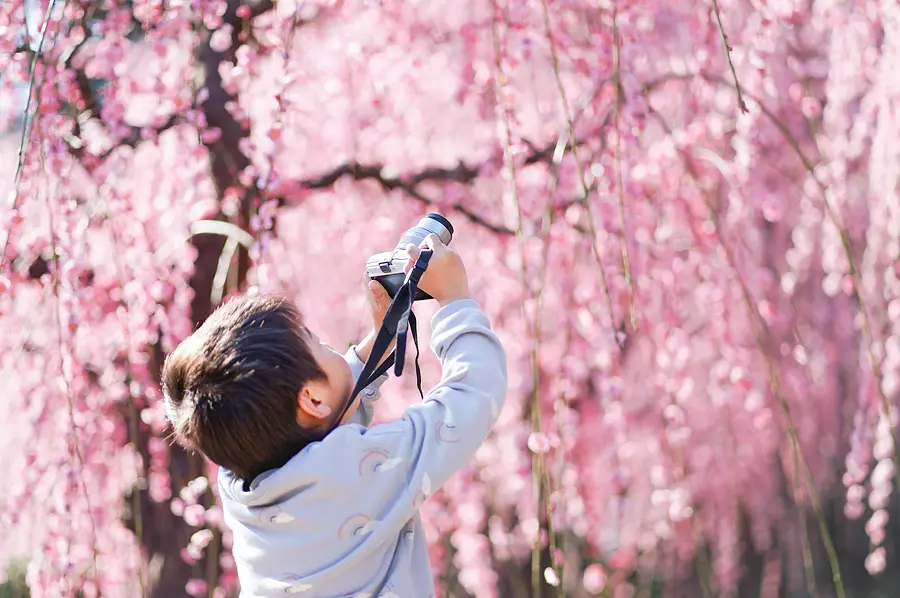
[163,235,506,598]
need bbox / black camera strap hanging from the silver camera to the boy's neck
[334,249,433,426]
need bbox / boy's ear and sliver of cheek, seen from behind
[297,332,359,427]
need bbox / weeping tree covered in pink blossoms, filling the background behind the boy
[0,0,900,598]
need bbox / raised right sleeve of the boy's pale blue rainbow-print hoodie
[342,299,506,508]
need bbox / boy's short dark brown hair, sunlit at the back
[162,295,327,483]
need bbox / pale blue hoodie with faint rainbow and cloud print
[219,299,506,598]
